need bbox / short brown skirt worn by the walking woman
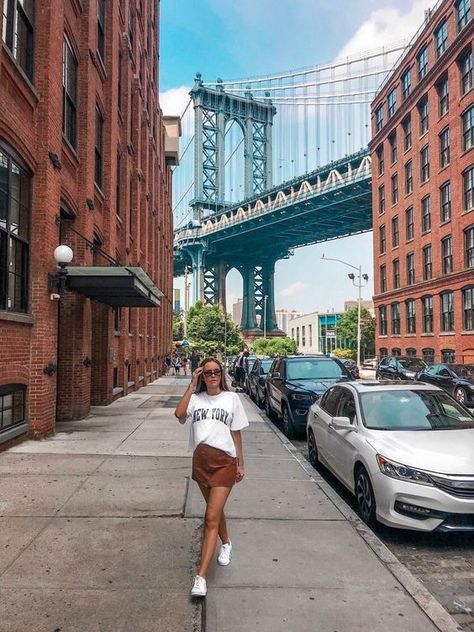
[192,443,237,487]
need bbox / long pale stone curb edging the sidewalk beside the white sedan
[258,409,462,632]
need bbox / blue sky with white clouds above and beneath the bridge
[160,0,435,312]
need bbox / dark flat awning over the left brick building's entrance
[66,266,163,307]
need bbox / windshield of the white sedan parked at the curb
[361,389,474,430]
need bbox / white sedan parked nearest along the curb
[307,381,474,531]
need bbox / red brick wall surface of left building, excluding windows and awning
[0,0,172,441]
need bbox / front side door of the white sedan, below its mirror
[327,386,358,488]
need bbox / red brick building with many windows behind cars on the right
[370,0,474,362]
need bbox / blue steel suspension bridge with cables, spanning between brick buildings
[173,42,408,336]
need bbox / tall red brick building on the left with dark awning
[0,0,179,443]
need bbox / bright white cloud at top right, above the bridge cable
[337,0,435,58]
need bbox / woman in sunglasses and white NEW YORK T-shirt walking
[174,358,249,597]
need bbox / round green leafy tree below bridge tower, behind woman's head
[187,301,244,356]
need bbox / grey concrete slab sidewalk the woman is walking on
[0,377,459,632]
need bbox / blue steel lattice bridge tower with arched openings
[186,73,283,337]
